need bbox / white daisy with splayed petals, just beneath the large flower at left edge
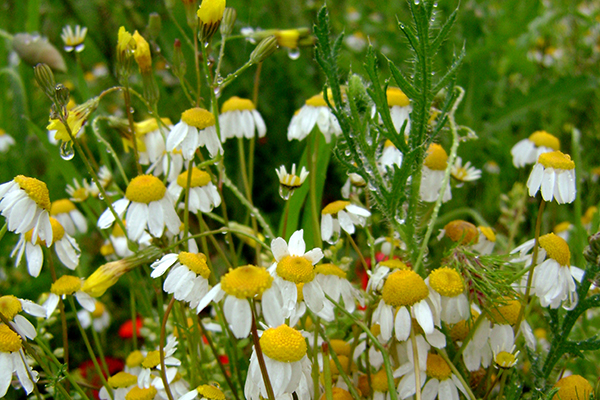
[10,217,81,277]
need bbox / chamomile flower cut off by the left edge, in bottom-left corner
[0,324,38,397]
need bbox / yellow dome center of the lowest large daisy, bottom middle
[260,324,307,363]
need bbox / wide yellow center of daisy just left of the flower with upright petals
[221,265,273,299]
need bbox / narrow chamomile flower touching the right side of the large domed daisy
[425,267,471,324]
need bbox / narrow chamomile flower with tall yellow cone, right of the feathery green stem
[419,143,452,203]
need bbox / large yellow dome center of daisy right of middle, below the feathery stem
[383,270,429,307]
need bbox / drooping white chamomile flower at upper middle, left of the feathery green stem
[288,93,342,143]
